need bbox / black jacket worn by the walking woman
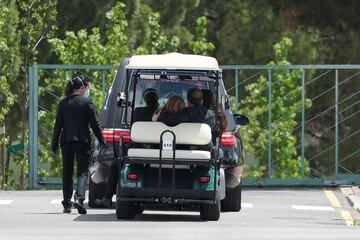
[52,95,104,152]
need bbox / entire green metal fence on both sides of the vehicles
[29,65,360,188]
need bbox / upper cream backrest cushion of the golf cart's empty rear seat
[131,122,211,145]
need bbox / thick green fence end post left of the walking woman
[28,67,35,189]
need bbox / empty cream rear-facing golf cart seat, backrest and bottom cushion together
[127,122,211,160]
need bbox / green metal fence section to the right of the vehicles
[222,65,360,185]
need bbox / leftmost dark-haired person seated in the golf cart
[134,88,159,122]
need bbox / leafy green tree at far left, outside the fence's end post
[1,0,56,188]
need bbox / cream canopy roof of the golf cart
[126,52,220,71]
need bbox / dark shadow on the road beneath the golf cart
[74,213,203,222]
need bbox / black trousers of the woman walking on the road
[62,142,90,207]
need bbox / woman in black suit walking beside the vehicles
[52,77,105,214]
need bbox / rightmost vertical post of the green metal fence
[335,69,339,180]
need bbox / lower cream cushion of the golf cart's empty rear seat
[128,148,211,160]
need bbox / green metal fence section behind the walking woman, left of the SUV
[28,64,117,188]
